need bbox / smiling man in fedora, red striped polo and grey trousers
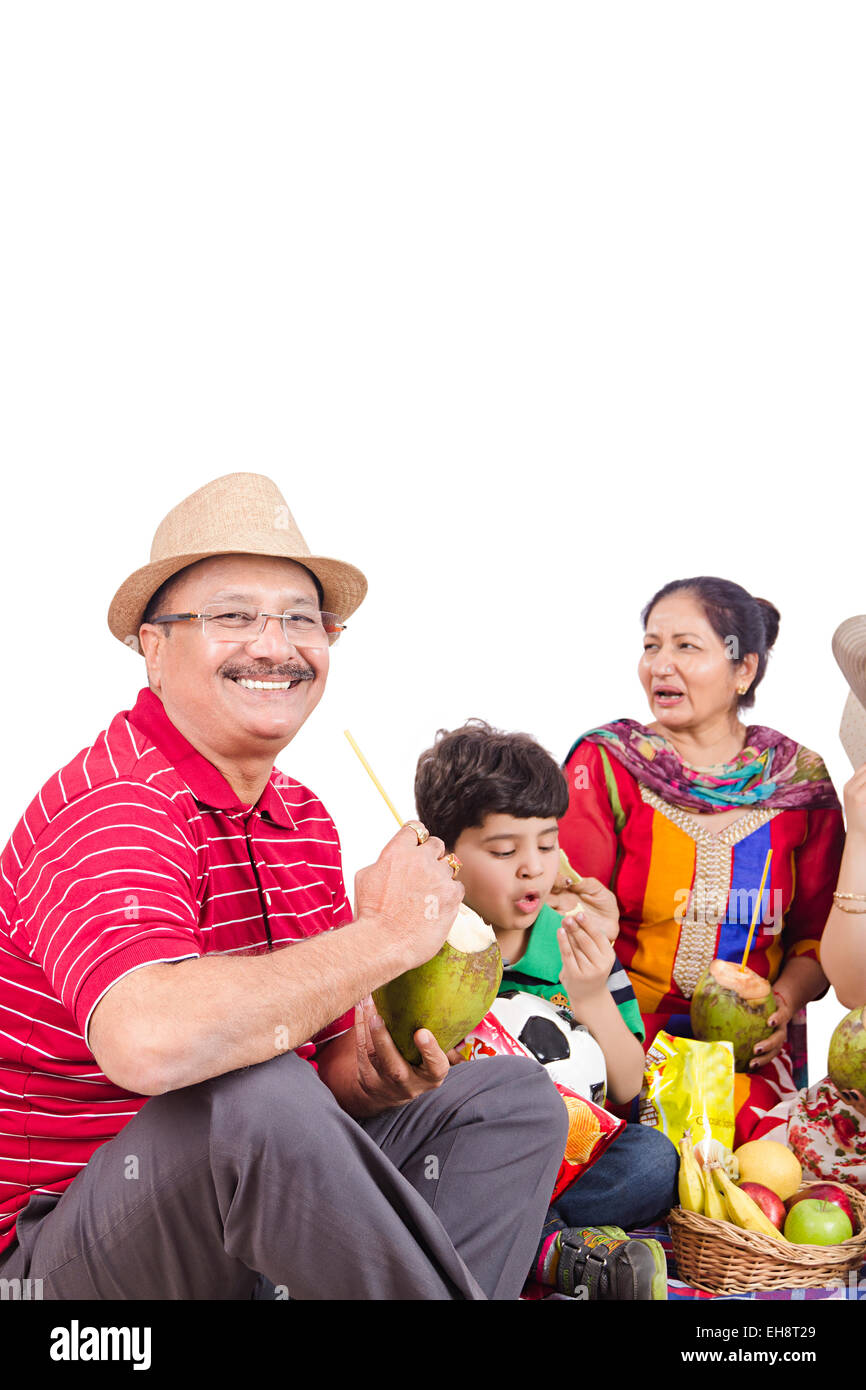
[0,474,566,1300]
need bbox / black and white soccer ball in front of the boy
[491,990,607,1105]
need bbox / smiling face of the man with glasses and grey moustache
[140,555,329,760]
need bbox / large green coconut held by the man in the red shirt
[373,904,502,1066]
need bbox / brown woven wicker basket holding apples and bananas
[667,1183,866,1294]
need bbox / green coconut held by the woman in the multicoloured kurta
[689,960,778,1072]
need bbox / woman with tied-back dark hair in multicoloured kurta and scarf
[560,578,844,1144]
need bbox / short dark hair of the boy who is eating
[416,719,569,851]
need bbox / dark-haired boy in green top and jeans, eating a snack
[416,720,678,1300]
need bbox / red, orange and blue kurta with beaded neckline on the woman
[560,741,844,1143]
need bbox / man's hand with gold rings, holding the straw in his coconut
[354,826,463,973]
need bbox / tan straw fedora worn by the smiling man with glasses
[108,473,367,651]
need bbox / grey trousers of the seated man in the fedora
[0,1052,567,1300]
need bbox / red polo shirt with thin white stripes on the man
[0,689,352,1252]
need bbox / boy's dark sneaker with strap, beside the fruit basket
[556,1226,667,1302]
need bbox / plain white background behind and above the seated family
[0,0,866,1079]
